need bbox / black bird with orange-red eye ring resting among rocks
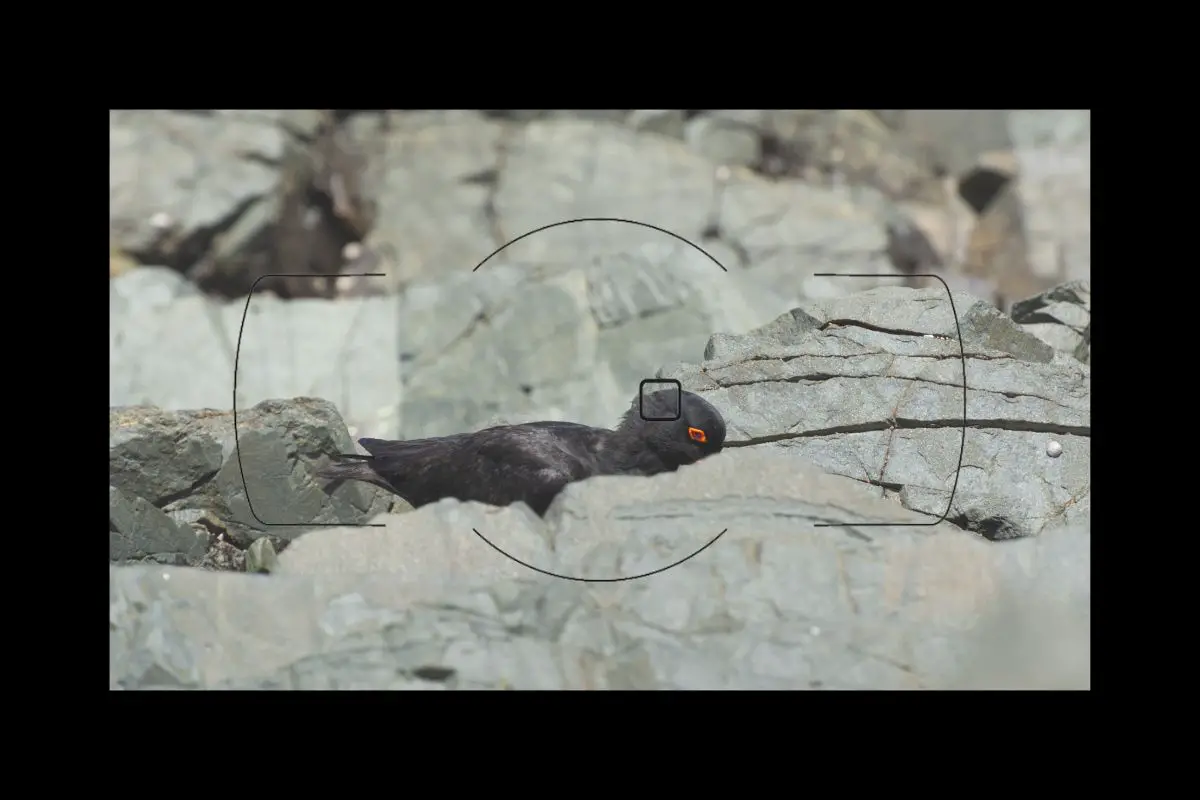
[317,390,725,516]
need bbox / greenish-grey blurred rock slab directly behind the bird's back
[388,255,786,438]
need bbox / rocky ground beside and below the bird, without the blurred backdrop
[109,288,1090,688]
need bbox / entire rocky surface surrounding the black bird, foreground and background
[109,109,1091,688]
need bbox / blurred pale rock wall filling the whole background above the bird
[109,109,1091,437]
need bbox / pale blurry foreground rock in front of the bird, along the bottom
[109,452,1090,688]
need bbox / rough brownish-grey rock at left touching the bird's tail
[109,398,391,548]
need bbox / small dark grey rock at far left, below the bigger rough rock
[108,486,205,566]
